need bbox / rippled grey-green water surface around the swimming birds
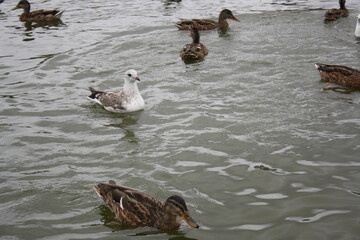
[0,0,360,240]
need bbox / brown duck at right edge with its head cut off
[315,63,360,88]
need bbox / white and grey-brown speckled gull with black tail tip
[88,69,145,113]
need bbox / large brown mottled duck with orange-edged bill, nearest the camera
[93,180,199,231]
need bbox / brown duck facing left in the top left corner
[12,0,64,22]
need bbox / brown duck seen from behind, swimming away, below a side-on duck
[180,27,209,62]
